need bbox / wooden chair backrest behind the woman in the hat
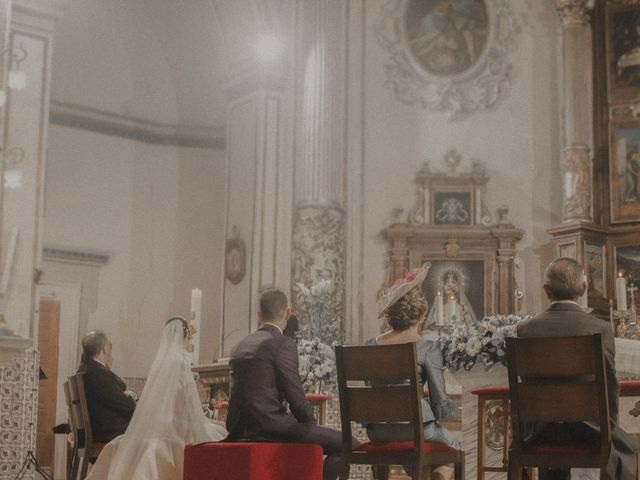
[335,343,424,453]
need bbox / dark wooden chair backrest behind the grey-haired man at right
[507,334,611,454]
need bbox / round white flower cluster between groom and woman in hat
[298,338,336,392]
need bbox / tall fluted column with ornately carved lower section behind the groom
[292,0,347,344]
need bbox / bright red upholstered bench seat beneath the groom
[184,442,322,480]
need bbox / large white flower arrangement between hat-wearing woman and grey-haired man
[438,315,526,372]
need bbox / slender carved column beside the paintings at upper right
[557,0,593,223]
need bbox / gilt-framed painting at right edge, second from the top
[609,121,640,223]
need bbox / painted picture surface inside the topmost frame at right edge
[609,7,640,94]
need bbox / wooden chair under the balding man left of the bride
[67,374,105,480]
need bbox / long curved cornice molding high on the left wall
[49,100,226,150]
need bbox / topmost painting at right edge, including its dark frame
[606,3,640,102]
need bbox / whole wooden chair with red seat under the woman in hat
[336,343,464,480]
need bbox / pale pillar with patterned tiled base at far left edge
[0,0,62,480]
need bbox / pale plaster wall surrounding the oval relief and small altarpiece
[362,0,562,338]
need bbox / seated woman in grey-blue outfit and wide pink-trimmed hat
[367,263,460,479]
